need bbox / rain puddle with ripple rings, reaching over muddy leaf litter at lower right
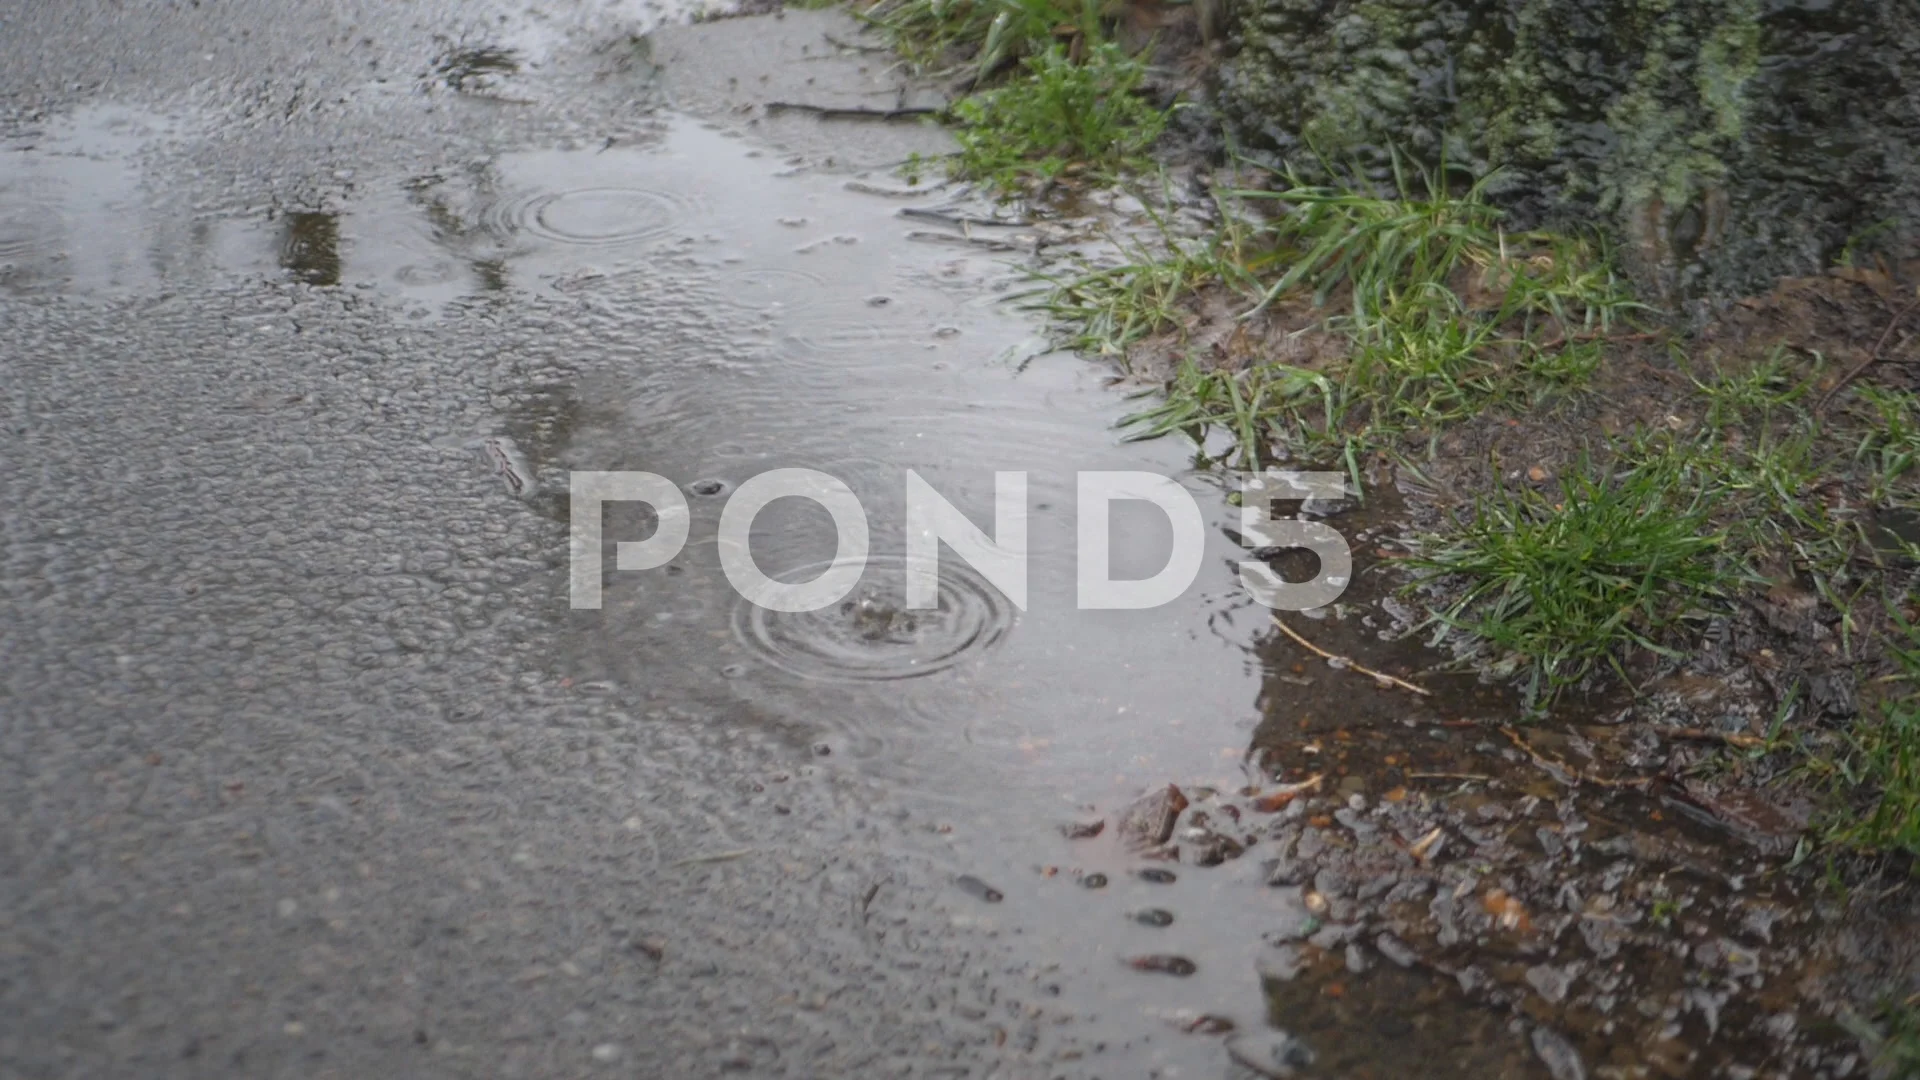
[0,84,1859,1080]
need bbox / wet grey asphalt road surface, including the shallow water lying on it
[0,0,1297,1080]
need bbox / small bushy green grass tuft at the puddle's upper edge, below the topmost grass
[952,42,1167,190]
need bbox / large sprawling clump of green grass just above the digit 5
[1067,169,1640,461]
